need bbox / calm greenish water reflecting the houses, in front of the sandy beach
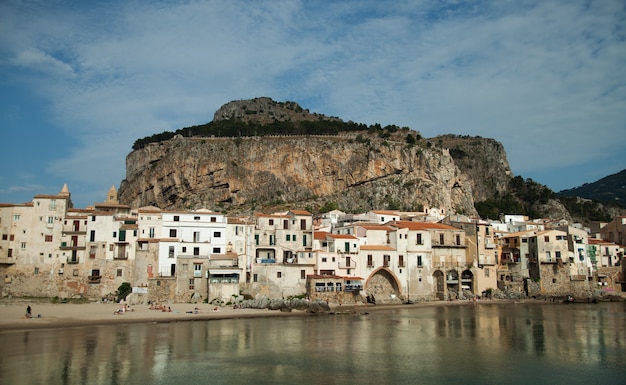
[0,303,626,385]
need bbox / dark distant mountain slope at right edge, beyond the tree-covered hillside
[557,169,626,207]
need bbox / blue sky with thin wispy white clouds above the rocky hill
[0,0,626,207]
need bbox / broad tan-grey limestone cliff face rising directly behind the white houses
[119,135,475,214]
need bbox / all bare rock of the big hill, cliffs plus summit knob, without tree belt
[119,98,510,215]
